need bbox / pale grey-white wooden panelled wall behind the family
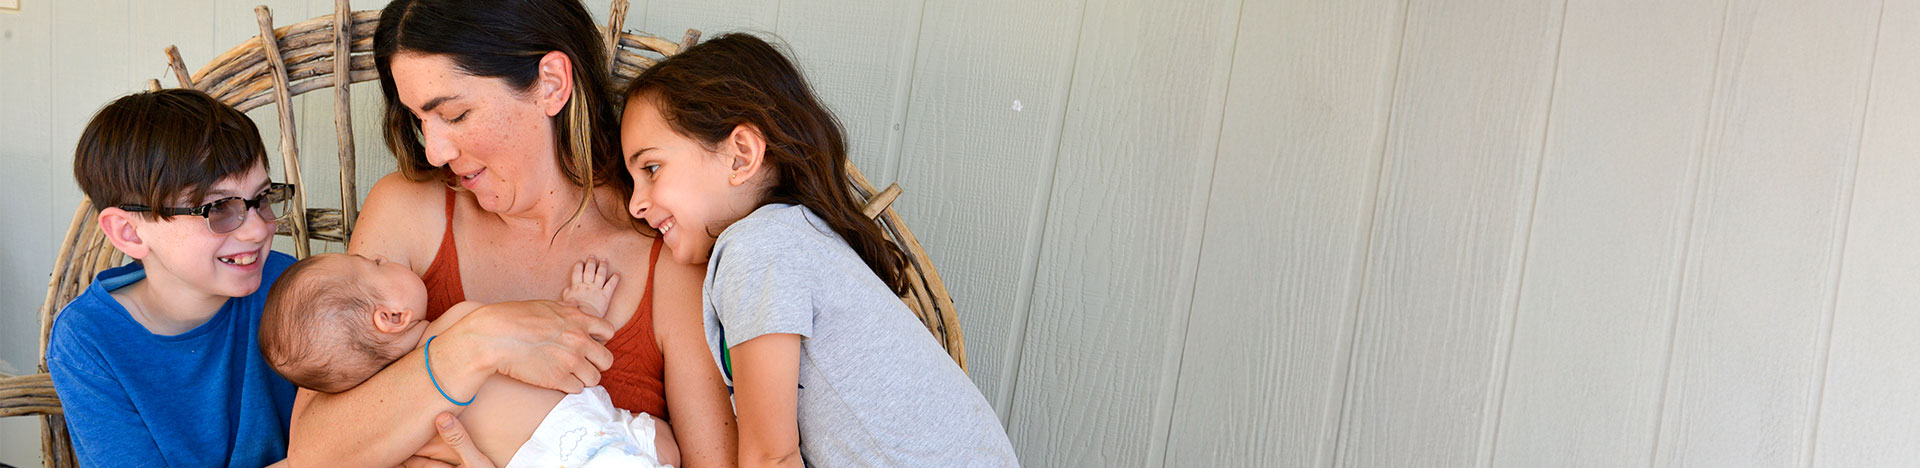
[0,0,1920,466]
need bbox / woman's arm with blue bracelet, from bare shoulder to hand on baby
[288,175,612,466]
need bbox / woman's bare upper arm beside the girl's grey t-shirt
[653,255,739,468]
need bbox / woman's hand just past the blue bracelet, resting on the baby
[447,301,614,393]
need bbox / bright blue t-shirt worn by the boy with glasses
[46,251,296,468]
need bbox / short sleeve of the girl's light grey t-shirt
[708,219,820,347]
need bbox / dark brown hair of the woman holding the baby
[372,0,632,224]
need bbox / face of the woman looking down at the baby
[392,52,564,213]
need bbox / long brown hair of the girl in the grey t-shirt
[624,33,906,293]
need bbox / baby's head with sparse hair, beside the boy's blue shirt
[259,253,426,393]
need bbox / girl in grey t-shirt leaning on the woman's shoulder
[620,35,1018,466]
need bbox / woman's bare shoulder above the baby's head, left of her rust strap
[348,173,447,272]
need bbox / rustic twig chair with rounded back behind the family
[0,0,966,466]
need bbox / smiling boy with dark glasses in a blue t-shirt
[46,90,296,466]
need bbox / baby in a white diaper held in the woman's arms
[259,253,680,466]
